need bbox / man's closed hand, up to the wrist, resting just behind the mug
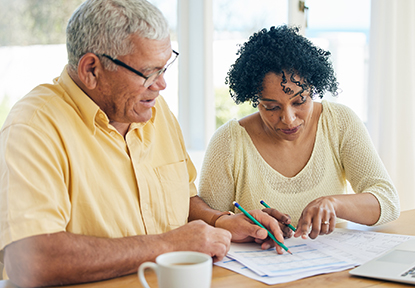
[162,220,232,261]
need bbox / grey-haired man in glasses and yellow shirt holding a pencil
[0,0,290,287]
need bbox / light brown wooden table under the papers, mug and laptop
[0,210,415,288]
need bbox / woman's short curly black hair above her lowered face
[225,25,338,107]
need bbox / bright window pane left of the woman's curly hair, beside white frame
[213,0,288,128]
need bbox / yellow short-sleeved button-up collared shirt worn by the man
[0,69,196,250]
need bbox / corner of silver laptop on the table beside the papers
[349,239,415,285]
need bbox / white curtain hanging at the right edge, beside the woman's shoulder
[368,0,415,210]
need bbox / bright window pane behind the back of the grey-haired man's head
[0,0,82,126]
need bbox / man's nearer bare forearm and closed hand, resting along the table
[4,221,231,287]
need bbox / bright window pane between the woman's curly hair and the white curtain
[306,0,370,121]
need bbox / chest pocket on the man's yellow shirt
[155,161,190,229]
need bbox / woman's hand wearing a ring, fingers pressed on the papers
[294,196,337,239]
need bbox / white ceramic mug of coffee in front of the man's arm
[138,251,212,288]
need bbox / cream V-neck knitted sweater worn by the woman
[199,101,400,225]
